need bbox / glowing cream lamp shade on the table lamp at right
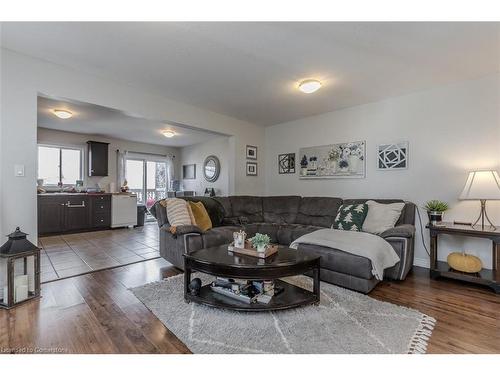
[460,171,500,200]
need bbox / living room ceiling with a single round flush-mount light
[1,22,500,126]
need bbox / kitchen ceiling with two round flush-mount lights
[38,96,226,147]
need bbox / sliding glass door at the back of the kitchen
[126,158,168,208]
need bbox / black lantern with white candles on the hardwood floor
[0,227,40,309]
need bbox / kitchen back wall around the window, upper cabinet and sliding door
[37,128,180,190]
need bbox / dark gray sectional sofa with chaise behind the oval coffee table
[151,196,415,293]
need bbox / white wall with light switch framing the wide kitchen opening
[0,49,264,239]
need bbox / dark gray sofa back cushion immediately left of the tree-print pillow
[295,197,342,228]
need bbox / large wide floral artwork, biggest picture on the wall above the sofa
[298,141,366,179]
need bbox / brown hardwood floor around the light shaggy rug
[0,259,500,353]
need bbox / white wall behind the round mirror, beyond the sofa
[179,137,229,196]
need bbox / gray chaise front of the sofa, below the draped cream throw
[298,244,373,279]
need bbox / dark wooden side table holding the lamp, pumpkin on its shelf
[426,223,500,293]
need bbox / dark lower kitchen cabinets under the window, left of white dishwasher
[38,194,111,234]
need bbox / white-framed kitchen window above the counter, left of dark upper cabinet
[38,145,82,186]
